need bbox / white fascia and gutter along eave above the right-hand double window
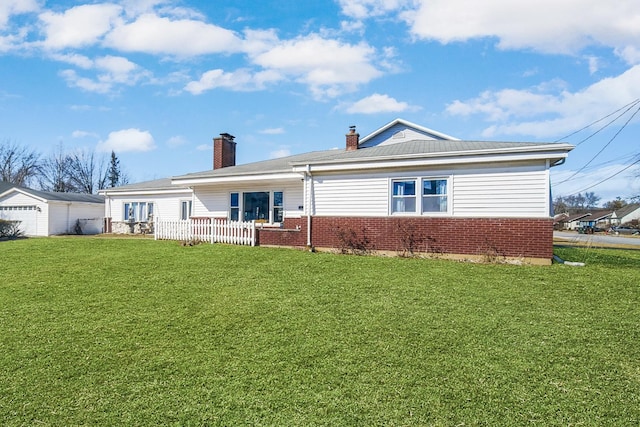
[293,151,568,173]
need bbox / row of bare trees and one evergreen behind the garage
[0,140,129,194]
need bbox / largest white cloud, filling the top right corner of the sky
[401,0,640,60]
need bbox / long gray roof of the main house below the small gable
[174,140,571,180]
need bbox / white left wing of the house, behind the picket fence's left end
[98,178,193,234]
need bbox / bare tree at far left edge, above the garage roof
[0,140,40,186]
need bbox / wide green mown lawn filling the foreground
[0,237,640,426]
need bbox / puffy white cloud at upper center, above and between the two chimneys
[252,34,382,97]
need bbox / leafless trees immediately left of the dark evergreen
[69,150,108,194]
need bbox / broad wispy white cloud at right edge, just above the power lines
[447,65,640,137]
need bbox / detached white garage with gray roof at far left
[0,182,104,236]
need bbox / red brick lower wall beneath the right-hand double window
[305,217,553,262]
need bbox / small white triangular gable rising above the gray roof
[359,119,458,148]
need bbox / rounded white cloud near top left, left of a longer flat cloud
[40,3,122,49]
